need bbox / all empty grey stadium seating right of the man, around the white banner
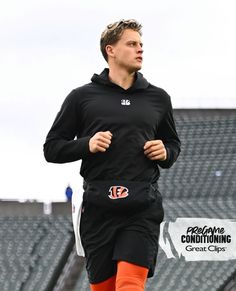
[153,110,236,291]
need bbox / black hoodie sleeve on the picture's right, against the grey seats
[157,95,181,168]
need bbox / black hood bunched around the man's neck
[91,68,149,91]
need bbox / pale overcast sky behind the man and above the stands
[0,0,236,200]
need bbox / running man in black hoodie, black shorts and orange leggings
[44,19,180,291]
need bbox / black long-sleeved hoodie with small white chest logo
[44,69,180,182]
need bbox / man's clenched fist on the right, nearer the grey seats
[143,139,167,161]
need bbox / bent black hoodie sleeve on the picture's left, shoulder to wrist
[44,90,91,163]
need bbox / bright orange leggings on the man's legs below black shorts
[90,261,148,291]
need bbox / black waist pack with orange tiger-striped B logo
[83,180,161,212]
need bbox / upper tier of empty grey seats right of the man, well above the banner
[159,110,236,199]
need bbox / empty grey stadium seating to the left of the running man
[0,202,74,291]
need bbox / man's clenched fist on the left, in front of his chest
[89,131,112,153]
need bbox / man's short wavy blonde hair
[100,19,142,61]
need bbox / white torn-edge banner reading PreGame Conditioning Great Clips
[159,218,236,261]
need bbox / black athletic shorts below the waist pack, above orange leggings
[80,194,164,284]
